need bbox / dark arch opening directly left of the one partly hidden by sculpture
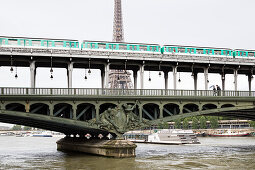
[76,103,96,121]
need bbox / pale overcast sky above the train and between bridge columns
[0,0,255,125]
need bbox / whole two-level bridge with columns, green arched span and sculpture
[0,42,255,155]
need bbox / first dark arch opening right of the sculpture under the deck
[142,103,160,120]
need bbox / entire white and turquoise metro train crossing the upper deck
[0,36,255,58]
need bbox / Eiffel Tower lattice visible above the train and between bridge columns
[109,0,133,89]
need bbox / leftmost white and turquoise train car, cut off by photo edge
[0,37,79,49]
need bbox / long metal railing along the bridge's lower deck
[0,87,255,97]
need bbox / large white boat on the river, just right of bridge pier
[124,129,200,145]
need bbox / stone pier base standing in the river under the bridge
[57,137,136,158]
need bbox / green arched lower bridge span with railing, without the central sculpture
[0,88,255,136]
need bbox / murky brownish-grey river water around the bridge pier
[0,136,255,170]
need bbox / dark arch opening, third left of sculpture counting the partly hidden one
[53,103,73,118]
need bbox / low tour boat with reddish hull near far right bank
[208,129,249,137]
